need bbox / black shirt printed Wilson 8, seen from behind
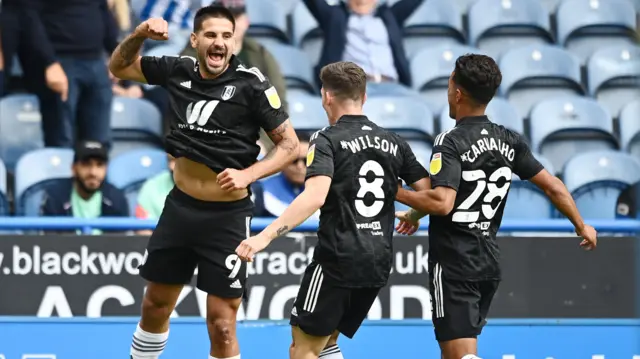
[306,116,428,287]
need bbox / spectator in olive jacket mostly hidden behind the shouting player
[181,0,288,152]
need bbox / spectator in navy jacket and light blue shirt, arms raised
[303,0,424,87]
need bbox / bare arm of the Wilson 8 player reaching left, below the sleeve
[236,176,331,262]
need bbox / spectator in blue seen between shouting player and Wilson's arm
[262,133,320,219]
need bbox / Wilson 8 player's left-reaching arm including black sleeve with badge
[236,135,334,261]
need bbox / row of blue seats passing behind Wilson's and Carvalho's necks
[0,93,640,176]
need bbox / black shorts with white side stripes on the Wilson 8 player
[289,262,380,338]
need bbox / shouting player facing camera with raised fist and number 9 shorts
[109,6,298,359]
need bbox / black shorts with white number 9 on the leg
[140,187,253,298]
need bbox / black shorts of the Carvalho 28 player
[429,264,500,342]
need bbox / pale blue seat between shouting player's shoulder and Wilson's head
[287,92,329,131]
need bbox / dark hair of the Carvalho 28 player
[453,54,502,105]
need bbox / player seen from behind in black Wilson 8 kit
[236,62,428,359]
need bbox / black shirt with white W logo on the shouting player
[141,56,289,172]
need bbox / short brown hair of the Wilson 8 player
[320,61,367,101]
